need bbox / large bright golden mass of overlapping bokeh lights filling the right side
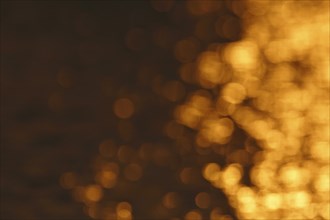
[175,0,330,219]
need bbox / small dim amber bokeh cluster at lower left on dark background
[60,139,143,220]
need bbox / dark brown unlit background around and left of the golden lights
[1,1,242,220]
